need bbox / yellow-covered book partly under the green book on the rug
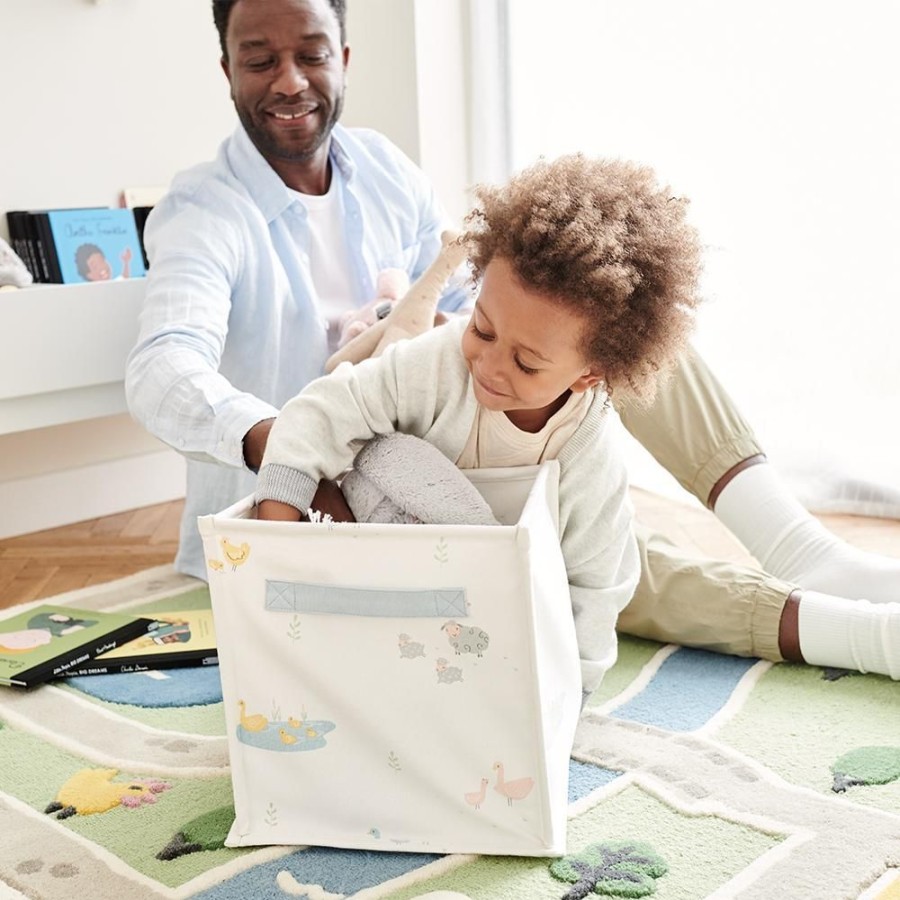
[63,609,219,678]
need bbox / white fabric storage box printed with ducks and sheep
[199,462,581,856]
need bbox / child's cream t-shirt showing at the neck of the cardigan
[456,391,591,469]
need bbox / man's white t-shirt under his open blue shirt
[290,178,356,353]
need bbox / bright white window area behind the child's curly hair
[510,0,900,509]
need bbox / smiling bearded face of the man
[222,0,349,169]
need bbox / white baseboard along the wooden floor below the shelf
[0,450,185,538]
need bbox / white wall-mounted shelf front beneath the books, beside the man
[0,278,145,434]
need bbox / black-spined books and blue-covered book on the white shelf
[6,207,149,284]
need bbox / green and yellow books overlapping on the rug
[0,604,218,688]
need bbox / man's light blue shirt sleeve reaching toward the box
[125,195,277,466]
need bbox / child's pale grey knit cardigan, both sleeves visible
[256,317,640,691]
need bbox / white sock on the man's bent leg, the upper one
[715,463,900,603]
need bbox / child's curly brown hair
[461,153,700,401]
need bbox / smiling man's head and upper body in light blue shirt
[126,0,469,578]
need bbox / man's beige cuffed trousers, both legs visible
[618,351,796,662]
